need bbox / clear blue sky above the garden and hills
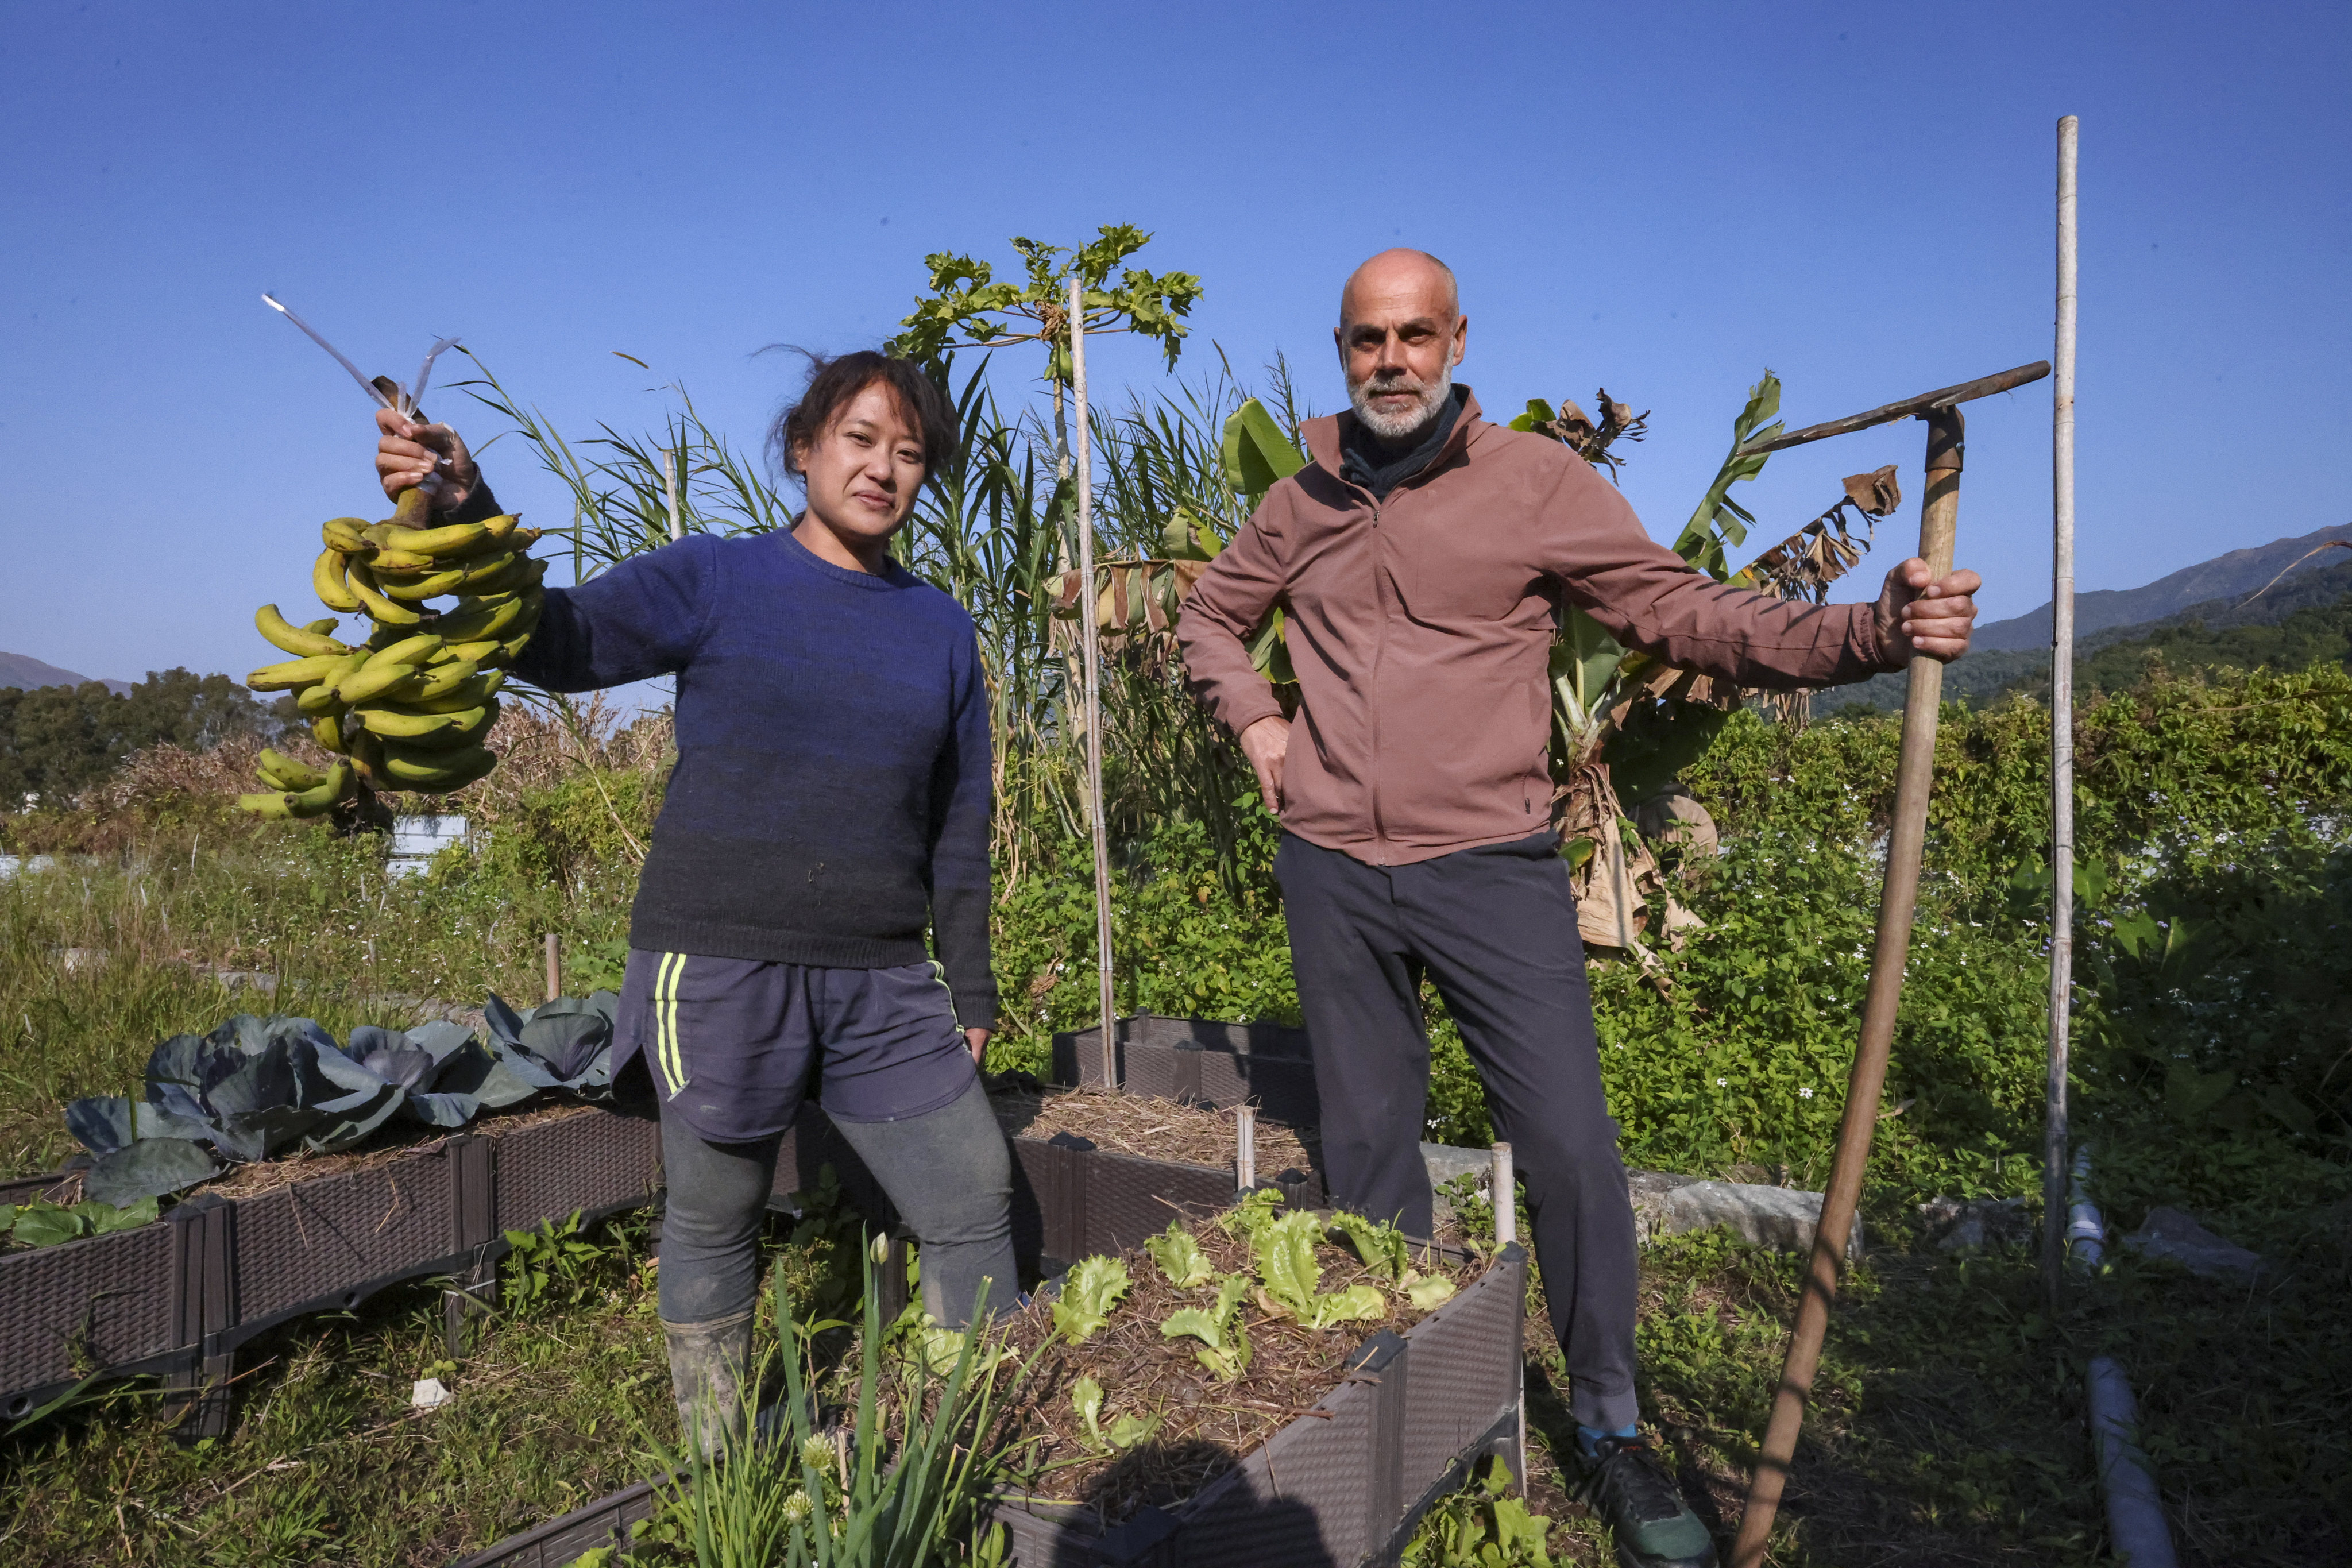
[0,0,2352,679]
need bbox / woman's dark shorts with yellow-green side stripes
[614,947,974,1142]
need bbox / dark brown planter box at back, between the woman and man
[1054,1013,1322,1126]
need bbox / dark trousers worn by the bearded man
[1275,832,1639,1432]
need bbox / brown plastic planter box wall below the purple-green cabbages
[0,1110,659,1427]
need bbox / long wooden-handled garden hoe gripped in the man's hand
[1731,360,2051,1568]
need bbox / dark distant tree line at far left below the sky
[0,670,292,811]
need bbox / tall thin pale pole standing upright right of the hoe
[2041,115,2077,1312]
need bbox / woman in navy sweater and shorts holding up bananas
[376,353,1016,1450]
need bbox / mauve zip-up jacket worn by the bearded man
[1176,388,1888,865]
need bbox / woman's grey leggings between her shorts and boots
[661,1079,1018,1328]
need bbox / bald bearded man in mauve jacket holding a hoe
[1179,249,1980,1568]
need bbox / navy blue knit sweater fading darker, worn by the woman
[503,515,997,1025]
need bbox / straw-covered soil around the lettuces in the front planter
[997,1220,1482,1525]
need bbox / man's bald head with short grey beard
[1331,249,1470,442]
